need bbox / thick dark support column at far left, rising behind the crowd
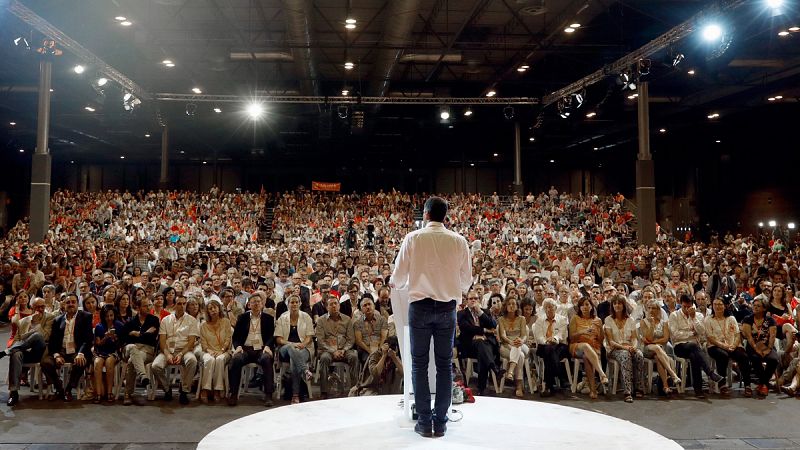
[29,60,53,243]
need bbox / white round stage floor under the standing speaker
[197,395,681,450]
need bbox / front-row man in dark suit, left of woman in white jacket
[228,295,275,407]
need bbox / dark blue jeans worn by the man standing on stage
[408,299,456,428]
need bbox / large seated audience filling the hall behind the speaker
[0,188,800,406]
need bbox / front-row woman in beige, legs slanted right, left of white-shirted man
[639,300,681,396]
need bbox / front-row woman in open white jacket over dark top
[275,294,314,404]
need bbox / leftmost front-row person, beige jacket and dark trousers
[0,294,55,406]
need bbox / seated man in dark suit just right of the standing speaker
[458,291,504,395]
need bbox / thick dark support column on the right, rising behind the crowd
[636,81,656,244]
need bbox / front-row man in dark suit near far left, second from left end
[42,293,93,402]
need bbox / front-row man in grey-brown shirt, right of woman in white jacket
[316,296,358,399]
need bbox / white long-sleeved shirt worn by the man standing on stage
[392,222,472,302]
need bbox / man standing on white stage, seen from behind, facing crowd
[391,197,472,437]
